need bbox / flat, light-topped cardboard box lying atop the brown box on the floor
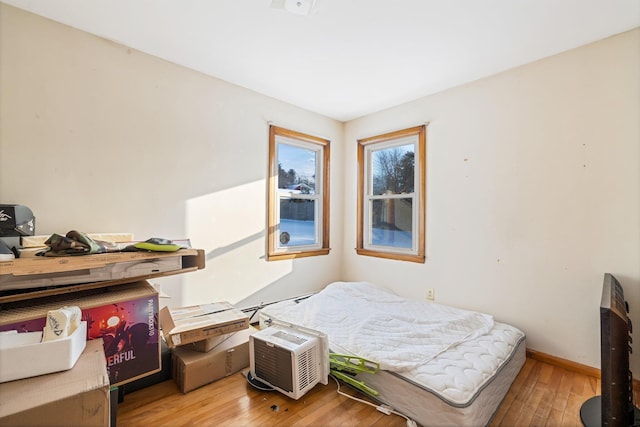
[160,302,249,348]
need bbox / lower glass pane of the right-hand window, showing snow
[371,198,413,249]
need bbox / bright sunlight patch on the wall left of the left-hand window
[180,180,293,305]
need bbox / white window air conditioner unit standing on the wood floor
[249,324,329,399]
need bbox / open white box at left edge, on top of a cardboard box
[0,322,87,383]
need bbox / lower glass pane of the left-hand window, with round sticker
[277,198,317,246]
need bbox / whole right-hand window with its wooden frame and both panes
[356,125,426,262]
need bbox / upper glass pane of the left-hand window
[278,143,317,194]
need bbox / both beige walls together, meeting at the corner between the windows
[0,4,640,376]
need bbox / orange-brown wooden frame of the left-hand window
[267,125,331,261]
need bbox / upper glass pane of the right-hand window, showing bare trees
[371,144,415,195]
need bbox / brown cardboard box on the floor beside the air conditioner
[172,326,257,393]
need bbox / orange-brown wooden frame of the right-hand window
[356,125,427,263]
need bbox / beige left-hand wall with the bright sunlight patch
[0,4,343,305]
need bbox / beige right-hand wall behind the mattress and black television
[344,30,640,377]
